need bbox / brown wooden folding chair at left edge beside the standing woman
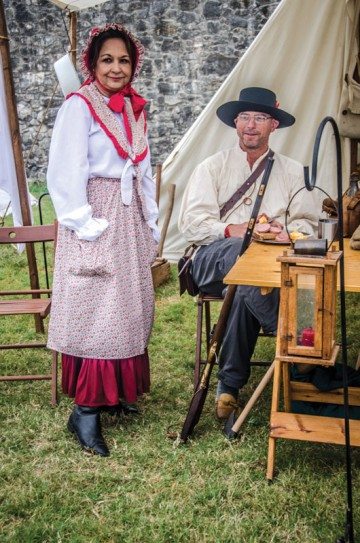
[0,224,57,405]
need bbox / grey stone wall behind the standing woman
[4,0,280,179]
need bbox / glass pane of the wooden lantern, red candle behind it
[296,274,316,347]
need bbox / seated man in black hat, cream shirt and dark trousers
[179,87,318,420]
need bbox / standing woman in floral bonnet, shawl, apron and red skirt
[47,24,159,456]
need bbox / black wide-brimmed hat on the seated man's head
[216,87,295,128]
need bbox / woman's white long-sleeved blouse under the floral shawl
[47,95,160,242]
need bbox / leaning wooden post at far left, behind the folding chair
[0,0,44,332]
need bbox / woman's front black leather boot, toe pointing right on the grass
[68,405,110,456]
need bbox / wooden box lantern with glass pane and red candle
[277,250,341,366]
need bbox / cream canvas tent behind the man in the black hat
[160,0,360,261]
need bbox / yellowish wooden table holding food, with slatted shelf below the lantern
[224,239,360,480]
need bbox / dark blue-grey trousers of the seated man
[192,238,279,389]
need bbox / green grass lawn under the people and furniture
[0,185,360,543]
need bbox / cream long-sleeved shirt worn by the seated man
[178,145,319,245]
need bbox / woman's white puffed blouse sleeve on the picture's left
[47,96,108,241]
